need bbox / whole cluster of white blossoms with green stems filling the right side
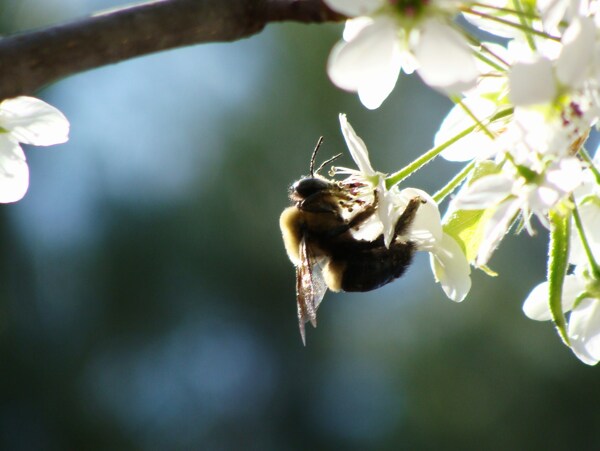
[325,0,600,364]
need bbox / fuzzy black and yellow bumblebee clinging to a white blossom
[279,138,424,345]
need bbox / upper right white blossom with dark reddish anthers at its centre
[503,17,600,157]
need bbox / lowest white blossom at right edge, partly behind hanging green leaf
[523,271,600,365]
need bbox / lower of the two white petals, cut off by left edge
[0,133,29,203]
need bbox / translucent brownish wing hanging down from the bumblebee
[296,238,327,346]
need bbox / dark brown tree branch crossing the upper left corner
[0,0,343,99]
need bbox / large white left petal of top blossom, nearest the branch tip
[327,16,401,109]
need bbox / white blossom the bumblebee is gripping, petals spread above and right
[335,114,471,302]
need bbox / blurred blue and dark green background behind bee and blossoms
[0,0,600,450]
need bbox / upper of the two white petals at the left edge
[0,96,69,146]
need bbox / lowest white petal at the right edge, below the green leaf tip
[567,298,600,365]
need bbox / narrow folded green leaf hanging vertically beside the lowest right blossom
[548,210,570,346]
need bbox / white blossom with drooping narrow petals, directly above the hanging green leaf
[454,157,582,266]
